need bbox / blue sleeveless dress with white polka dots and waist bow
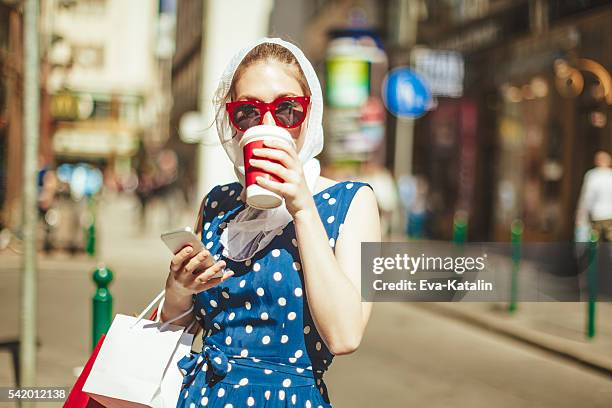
[177,181,369,408]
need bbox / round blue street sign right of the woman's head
[382,67,432,118]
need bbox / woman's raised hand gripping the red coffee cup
[250,140,316,218]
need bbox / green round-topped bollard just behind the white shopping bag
[92,265,113,350]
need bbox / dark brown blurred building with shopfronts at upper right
[408,0,612,241]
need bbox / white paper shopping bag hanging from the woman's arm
[83,291,195,408]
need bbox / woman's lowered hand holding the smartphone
[166,246,234,297]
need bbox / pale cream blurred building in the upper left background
[41,0,171,183]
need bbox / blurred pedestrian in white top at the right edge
[576,150,612,242]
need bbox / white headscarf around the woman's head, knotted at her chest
[214,38,323,261]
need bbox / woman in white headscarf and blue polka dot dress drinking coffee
[161,38,380,408]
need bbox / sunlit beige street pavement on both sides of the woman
[0,194,612,408]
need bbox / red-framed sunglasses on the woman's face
[225,96,310,132]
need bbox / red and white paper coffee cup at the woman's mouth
[240,125,295,210]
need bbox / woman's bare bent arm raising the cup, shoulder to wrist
[294,187,381,355]
